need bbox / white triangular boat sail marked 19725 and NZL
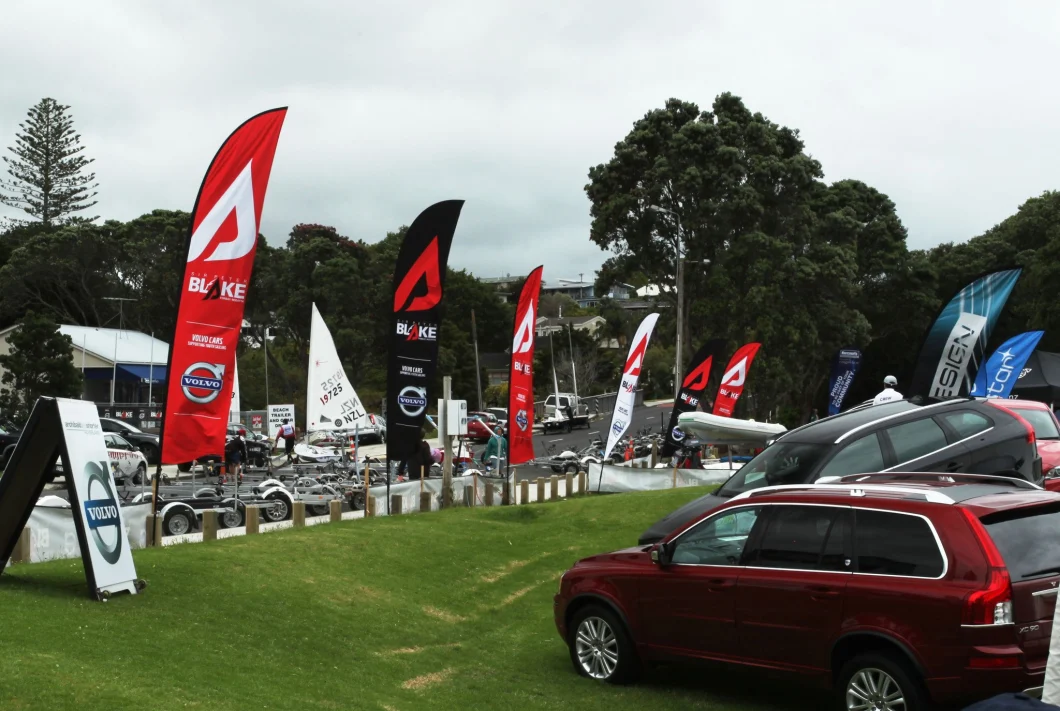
[305,304,368,432]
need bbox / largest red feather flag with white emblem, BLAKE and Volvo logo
[160,107,287,464]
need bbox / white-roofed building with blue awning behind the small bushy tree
[0,324,170,405]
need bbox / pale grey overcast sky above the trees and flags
[0,0,1060,281]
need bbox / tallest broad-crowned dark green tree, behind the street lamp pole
[585,93,930,416]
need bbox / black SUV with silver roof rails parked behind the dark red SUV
[638,397,1042,546]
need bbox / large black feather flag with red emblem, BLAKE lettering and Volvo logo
[387,200,463,461]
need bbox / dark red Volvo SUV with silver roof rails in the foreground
[554,473,1060,711]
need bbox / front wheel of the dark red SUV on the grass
[567,605,640,683]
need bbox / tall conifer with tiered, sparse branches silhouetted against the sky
[0,99,98,228]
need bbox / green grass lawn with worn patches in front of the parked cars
[0,488,824,711]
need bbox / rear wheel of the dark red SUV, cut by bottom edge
[835,652,929,711]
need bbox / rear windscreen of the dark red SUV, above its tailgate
[983,505,1060,581]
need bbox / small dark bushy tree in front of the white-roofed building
[0,312,82,425]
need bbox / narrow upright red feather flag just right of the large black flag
[508,267,542,464]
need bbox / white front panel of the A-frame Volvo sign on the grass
[55,397,136,594]
